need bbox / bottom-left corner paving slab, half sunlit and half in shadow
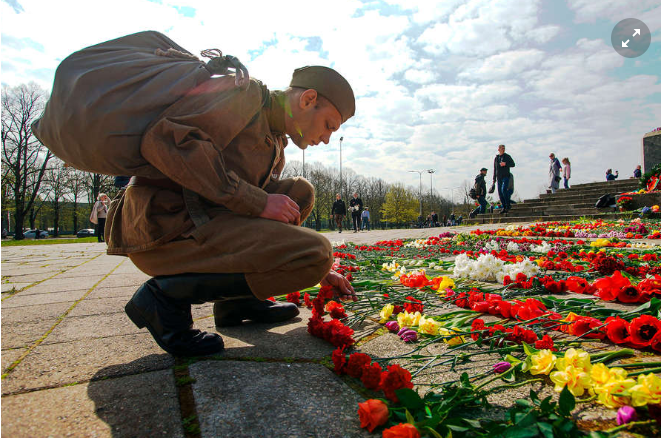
[2,370,183,437]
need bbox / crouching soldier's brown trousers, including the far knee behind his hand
[129,178,333,300]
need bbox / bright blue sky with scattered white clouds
[0,0,661,198]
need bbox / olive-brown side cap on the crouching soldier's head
[289,66,356,123]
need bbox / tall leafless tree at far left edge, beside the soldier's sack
[2,83,52,239]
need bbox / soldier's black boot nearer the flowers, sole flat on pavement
[213,297,299,328]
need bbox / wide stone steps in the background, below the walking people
[464,178,639,224]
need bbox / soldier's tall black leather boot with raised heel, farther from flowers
[125,273,254,357]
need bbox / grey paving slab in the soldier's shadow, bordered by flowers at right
[189,361,371,437]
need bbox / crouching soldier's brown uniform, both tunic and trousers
[106,76,332,299]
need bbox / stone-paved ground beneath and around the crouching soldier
[1,224,648,437]
